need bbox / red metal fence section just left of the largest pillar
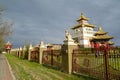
[42,50,62,69]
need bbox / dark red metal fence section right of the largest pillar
[73,49,120,80]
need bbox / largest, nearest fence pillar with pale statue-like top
[62,31,78,74]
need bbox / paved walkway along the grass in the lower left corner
[0,54,13,80]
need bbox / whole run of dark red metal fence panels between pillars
[11,47,120,80]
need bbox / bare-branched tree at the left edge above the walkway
[0,7,12,51]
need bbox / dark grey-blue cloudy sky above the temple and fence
[0,0,120,46]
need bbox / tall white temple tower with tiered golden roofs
[72,13,95,48]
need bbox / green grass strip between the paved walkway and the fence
[6,54,94,80]
